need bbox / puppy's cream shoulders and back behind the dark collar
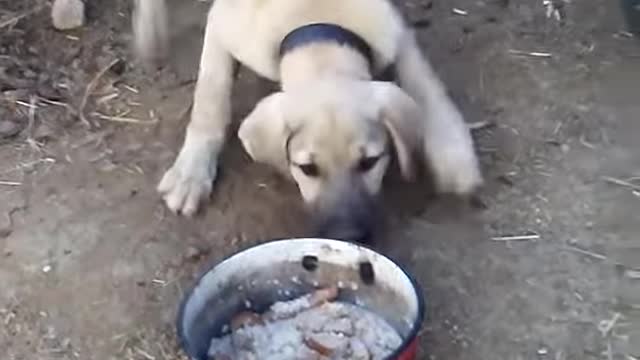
[195,0,404,80]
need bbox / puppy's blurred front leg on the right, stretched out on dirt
[396,33,482,194]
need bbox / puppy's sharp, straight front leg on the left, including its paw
[154,16,233,216]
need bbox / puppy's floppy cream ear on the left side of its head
[238,92,291,170]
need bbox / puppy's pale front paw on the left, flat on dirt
[158,141,217,216]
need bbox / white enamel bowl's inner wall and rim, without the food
[177,239,424,360]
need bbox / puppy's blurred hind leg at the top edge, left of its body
[132,0,169,65]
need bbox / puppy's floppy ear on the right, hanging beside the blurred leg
[372,82,424,180]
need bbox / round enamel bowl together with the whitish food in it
[177,239,424,360]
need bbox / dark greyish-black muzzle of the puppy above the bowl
[314,180,378,243]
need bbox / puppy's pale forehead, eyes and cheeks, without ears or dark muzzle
[285,100,389,204]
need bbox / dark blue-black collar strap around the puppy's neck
[280,23,374,67]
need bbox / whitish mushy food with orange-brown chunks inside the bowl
[209,287,402,360]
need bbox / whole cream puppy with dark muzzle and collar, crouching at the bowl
[133,0,483,241]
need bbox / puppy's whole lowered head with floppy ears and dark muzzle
[238,81,423,241]
